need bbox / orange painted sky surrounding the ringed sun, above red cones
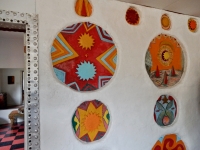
[149,34,183,71]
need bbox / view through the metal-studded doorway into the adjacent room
[0,31,25,149]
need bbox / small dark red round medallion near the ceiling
[126,7,140,25]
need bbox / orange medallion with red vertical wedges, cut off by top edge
[75,0,92,17]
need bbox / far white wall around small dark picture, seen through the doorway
[1,68,23,106]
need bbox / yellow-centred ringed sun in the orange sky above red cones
[158,45,173,66]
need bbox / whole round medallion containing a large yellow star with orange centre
[72,100,110,142]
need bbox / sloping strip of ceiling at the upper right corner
[118,0,200,17]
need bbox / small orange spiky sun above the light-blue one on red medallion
[78,33,94,50]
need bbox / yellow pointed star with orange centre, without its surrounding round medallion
[78,103,106,141]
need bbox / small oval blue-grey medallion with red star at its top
[154,95,177,126]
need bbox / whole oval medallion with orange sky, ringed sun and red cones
[145,34,184,88]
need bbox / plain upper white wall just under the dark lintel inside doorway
[0,31,25,68]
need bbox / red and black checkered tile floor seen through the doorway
[0,122,24,150]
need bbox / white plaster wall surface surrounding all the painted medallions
[20,0,200,150]
